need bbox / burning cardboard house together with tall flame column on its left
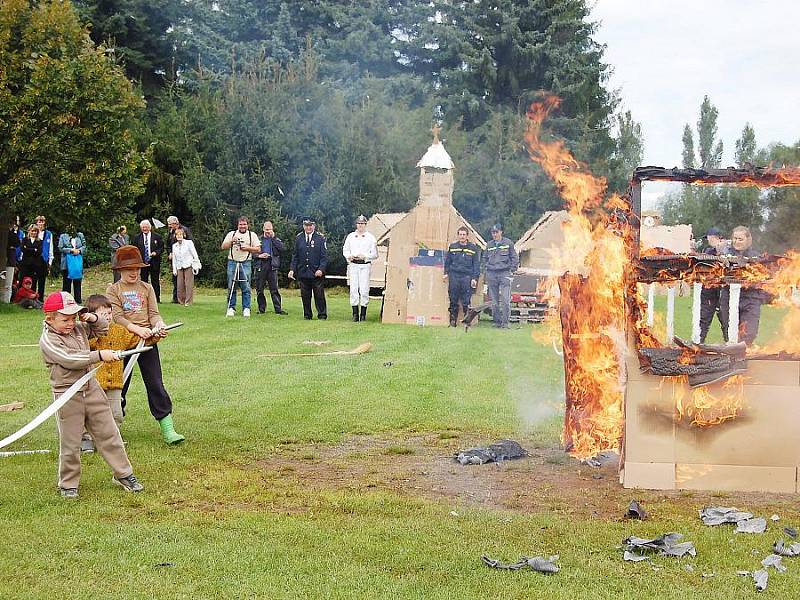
[526,97,800,492]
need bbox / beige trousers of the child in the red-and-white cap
[56,379,133,488]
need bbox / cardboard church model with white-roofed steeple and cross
[383,127,486,326]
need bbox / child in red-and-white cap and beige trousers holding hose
[39,292,144,498]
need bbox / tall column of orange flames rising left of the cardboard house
[525,96,629,458]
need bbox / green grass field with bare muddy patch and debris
[0,279,800,599]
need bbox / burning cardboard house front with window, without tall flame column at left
[621,167,800,492]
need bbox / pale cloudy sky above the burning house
[590,0,800,208]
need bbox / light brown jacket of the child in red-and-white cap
[39,315,108,394]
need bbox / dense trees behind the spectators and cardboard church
[0,0,642,281]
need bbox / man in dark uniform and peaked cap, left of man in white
[289,217,328,320]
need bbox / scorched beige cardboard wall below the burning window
[621,346,800,493]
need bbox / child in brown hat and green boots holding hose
[106,245,186,444]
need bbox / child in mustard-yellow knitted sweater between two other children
[81,294,139,452]
